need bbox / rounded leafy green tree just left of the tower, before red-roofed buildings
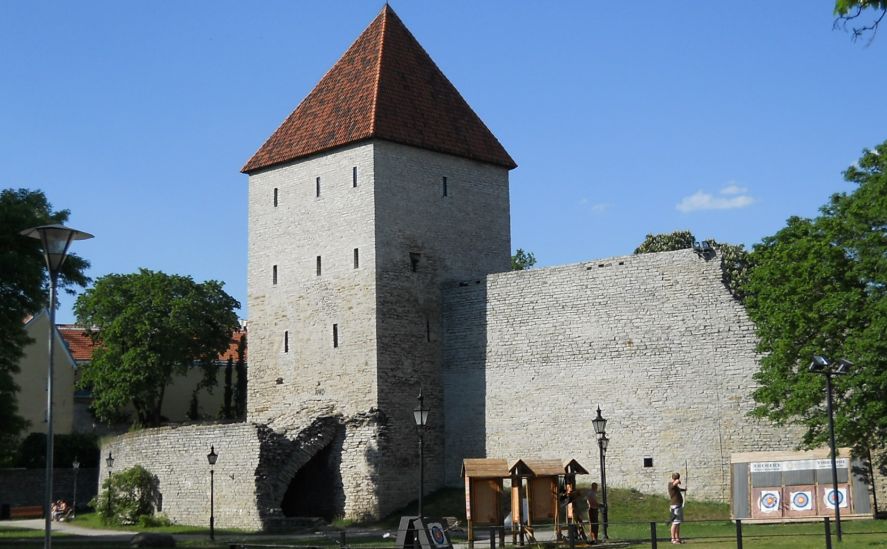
[74,269,240,426]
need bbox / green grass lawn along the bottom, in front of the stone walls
[0,488,887,549]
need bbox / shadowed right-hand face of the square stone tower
[375,141,511,513]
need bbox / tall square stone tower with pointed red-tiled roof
[242,5,516,517]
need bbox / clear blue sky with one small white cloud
[0,0,887,322]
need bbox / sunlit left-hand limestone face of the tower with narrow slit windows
[247,143,376,428]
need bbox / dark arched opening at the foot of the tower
[280,434,342,522]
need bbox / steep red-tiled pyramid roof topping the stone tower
[241,4,517,173]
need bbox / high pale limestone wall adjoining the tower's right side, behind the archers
[443,250,798,500]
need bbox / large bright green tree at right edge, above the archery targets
[745,142,887,467]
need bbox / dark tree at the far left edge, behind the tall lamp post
[0,189,89,462]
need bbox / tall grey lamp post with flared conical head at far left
[19,225,92,549]
